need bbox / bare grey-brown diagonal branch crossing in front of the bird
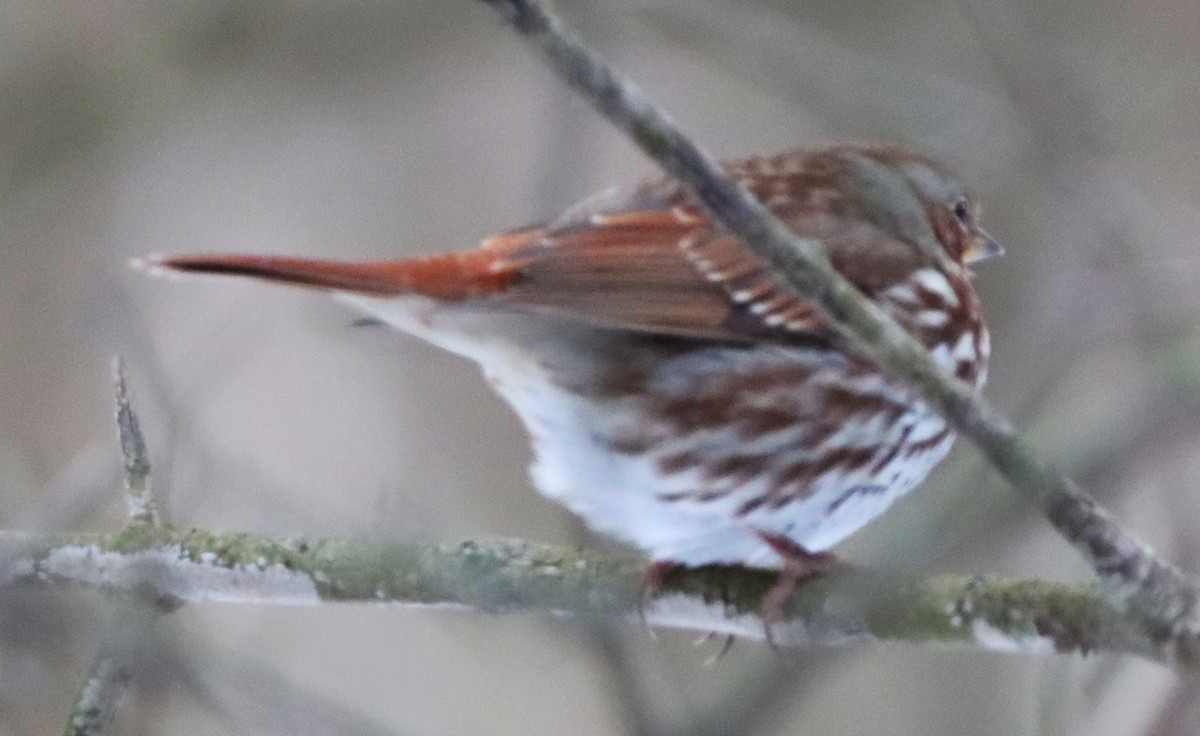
[472,0,1200,658]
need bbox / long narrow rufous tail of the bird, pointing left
[146,231,536,301]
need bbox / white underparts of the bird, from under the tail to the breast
[338,297,953,568]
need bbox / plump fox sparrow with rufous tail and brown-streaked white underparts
[145,144,1001,598]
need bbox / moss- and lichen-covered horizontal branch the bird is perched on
[0,525,1171,671]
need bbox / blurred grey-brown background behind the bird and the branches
[0,0,1200,736]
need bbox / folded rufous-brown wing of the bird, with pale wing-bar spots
[493,200,824,340]
